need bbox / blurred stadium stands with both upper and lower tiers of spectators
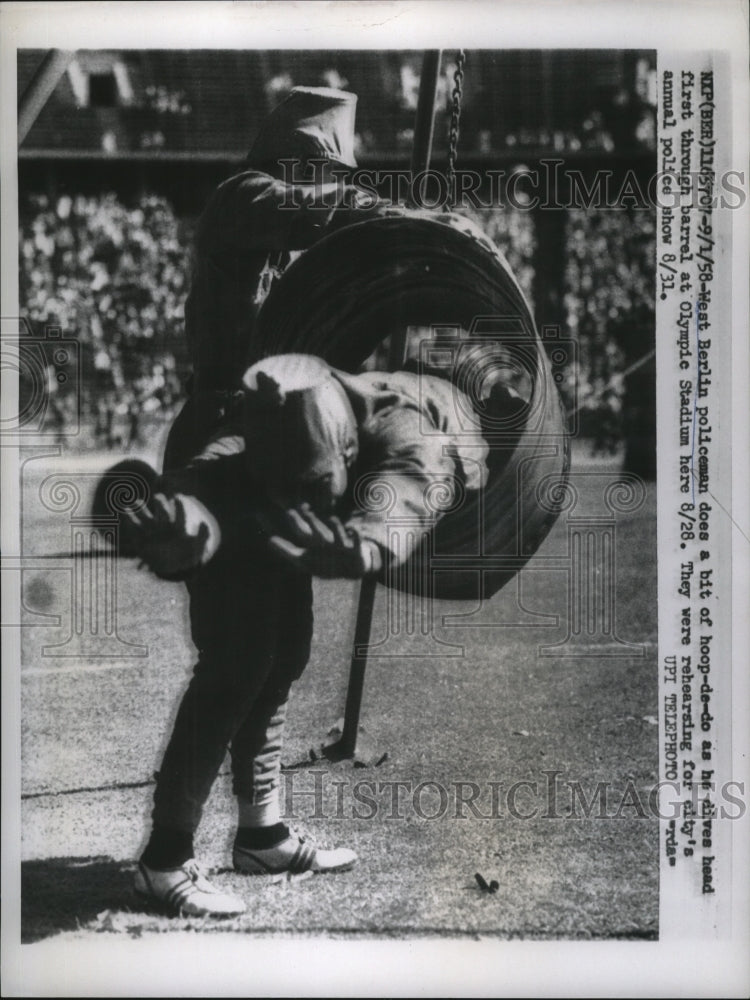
[19,52,655,474]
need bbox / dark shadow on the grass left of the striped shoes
[21,855,133,944]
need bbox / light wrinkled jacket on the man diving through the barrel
[159,370,488,565]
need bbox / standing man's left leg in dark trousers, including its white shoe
[136,557,309,915]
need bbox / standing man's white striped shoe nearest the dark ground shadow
[135,859,246,917]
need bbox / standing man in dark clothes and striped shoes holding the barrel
[136,87,388,915]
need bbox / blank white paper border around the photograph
[0,0,750,997]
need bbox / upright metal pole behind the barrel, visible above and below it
[329,49,442,758]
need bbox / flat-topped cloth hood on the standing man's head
[247,87,357,179]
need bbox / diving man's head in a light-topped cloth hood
[243,354,358,514]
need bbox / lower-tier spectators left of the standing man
[20,193,192,447]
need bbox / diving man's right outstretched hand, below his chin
[269,504,382,580]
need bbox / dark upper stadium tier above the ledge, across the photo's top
[18,49,655,163]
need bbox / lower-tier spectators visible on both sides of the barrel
[20,187,655,449]
